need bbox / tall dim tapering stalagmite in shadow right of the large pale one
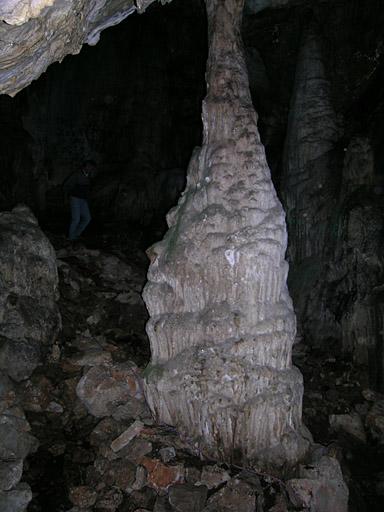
[283,28,340,263]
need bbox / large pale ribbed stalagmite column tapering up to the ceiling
[144,0,308,468]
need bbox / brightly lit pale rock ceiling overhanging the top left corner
[0,0,311,96]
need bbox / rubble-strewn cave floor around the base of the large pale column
[15,235,384,512]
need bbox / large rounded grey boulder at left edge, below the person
[0,207,60,381]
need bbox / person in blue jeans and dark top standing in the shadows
[63,160,96,240]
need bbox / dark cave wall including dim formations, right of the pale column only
[244,1,384,389]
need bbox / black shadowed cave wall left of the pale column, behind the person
[0,2,207,224]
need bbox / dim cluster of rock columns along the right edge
[281,20,383,388]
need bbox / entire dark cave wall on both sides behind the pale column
[0,0,384,388]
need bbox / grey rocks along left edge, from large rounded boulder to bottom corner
[0,206,60,512]
